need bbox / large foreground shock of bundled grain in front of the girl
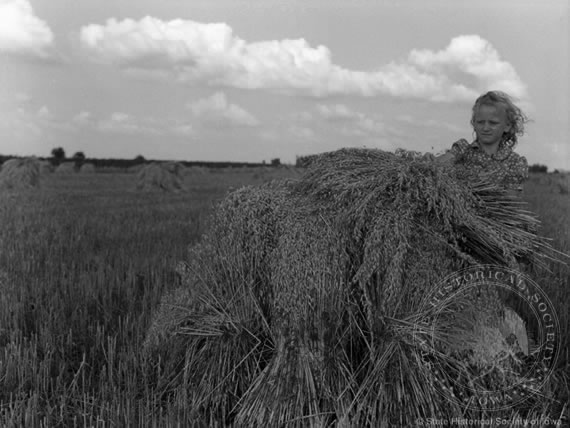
[147,149,560,426]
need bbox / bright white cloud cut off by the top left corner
[0,0,54,59]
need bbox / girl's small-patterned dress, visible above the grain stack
[450,139,528,191]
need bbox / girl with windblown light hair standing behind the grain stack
[436,91,528,191]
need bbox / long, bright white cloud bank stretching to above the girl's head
[80,16,527,101]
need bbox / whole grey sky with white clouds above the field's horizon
[0,0,570,170]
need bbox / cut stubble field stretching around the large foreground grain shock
[0,170,570,427]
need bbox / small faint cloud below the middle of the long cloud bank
[188,92,259,126]
